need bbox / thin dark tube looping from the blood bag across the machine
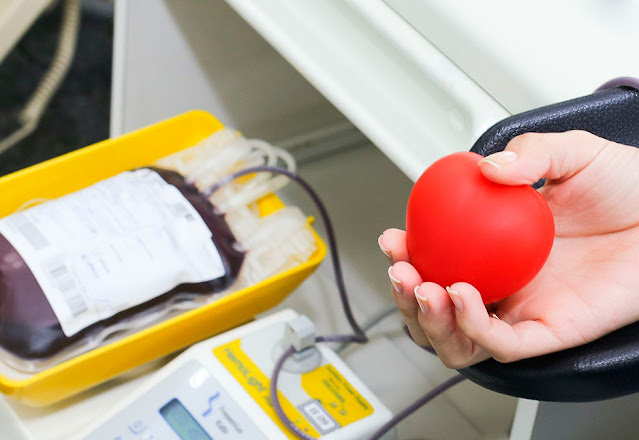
[210,166,465,440]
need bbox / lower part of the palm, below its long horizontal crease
[494,228,639,348]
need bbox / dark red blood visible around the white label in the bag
[0,169,244,359]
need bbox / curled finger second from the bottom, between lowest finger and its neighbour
[415,282,489,369]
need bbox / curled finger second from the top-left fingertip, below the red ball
[388,262,431,347]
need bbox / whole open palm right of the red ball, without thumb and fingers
[493,144,639,358]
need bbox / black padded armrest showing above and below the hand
[460,80,639,402]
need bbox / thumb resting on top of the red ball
[478,131,612,185]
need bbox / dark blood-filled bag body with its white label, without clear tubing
[0,168,244,359]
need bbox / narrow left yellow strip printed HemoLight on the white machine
[213,339,320,440]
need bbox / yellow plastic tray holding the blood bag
[0,111,326,406]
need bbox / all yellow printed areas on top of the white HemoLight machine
[213,339,373,439]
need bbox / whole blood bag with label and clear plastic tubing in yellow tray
[0,129,316,372]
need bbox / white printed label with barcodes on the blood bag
[0,169,225,336]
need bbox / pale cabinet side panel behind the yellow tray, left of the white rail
[111,0,344,140]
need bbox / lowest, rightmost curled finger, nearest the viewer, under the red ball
[450,283,564,362]
